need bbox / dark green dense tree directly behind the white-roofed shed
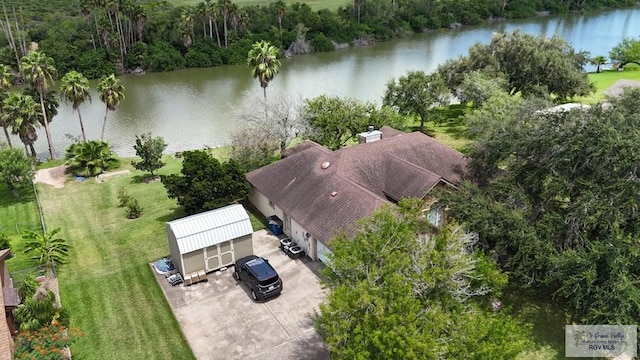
[160,150,250,214]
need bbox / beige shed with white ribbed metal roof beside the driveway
[167,204,253,275]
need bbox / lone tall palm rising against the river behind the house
[247,40,280,116]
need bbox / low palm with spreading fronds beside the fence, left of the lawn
[22,228,71,272]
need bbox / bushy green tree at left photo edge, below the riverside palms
[0,143,34,198]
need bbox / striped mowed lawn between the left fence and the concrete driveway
[38,156,194,359]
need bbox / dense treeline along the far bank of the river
[0,0,636,78]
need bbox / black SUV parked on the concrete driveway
[233,255,282,301]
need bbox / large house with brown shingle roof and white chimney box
[247,127,467,262]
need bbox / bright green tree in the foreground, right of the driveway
[315,202,531,359]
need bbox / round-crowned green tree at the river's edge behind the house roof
[382,71,450,131]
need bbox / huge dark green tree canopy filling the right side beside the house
[440,89,640,324]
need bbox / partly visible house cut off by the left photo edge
[0,249,20,360]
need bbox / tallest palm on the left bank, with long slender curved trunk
[20,51,57,160]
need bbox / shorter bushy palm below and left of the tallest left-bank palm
[3,92,40,158]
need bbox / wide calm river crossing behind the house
[13,8,640,158]
